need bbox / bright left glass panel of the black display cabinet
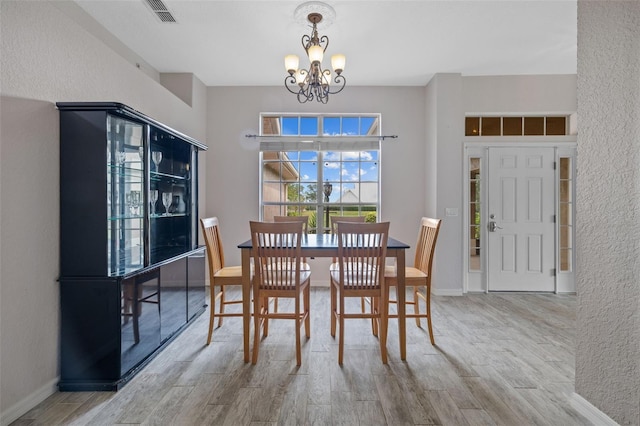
[107,115,147,276]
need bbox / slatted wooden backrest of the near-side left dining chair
[249,221,308,290]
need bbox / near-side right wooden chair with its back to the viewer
[330,222,389,365]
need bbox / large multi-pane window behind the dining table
[260,114,381,233]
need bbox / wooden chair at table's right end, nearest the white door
[384,217,442,345]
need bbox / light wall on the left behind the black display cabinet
[0,0,206,424]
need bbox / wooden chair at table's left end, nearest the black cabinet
[200,217,249,345]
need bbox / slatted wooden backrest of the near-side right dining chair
[337,222,389,290]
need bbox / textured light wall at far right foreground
[576,1,640,425]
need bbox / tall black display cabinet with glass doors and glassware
[56,102,207,391]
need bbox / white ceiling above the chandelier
[67,0,577,86]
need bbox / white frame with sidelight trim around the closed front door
[462,135,577,293]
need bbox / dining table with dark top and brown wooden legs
[238,234,410,362]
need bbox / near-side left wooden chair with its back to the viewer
[249,221,311,365]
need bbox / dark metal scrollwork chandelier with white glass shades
[284,12,346,104]
